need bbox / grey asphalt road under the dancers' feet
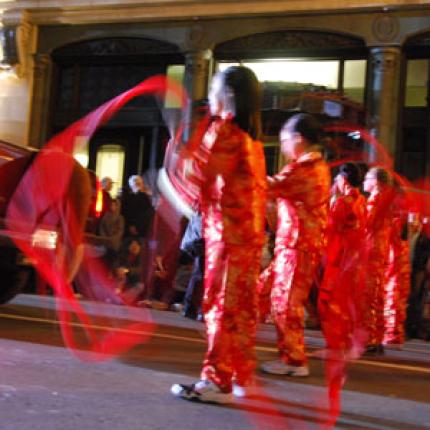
[0,295,430,430]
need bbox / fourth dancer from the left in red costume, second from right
[363,167,393,354]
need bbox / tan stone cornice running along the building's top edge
[0,0,430,25]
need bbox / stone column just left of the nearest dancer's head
[184,50,212,140]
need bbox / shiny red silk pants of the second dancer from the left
[271,248,320,366]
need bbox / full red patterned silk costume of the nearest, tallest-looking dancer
[189,119,266,392]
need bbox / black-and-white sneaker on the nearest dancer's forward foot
[170,381,233,404]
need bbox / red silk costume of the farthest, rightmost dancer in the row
[384,218,411,345]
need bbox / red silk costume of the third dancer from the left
[318,186,366,352]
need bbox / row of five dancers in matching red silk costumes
[171,66,409,403]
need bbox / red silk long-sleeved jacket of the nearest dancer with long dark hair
[189,119,266,245]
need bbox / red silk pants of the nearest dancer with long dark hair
[201,241,261,392]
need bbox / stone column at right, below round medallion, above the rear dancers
[367,47,401,159]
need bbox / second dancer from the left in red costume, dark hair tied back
[261,114,330,376]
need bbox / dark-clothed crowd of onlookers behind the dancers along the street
[92,170,430,339]
